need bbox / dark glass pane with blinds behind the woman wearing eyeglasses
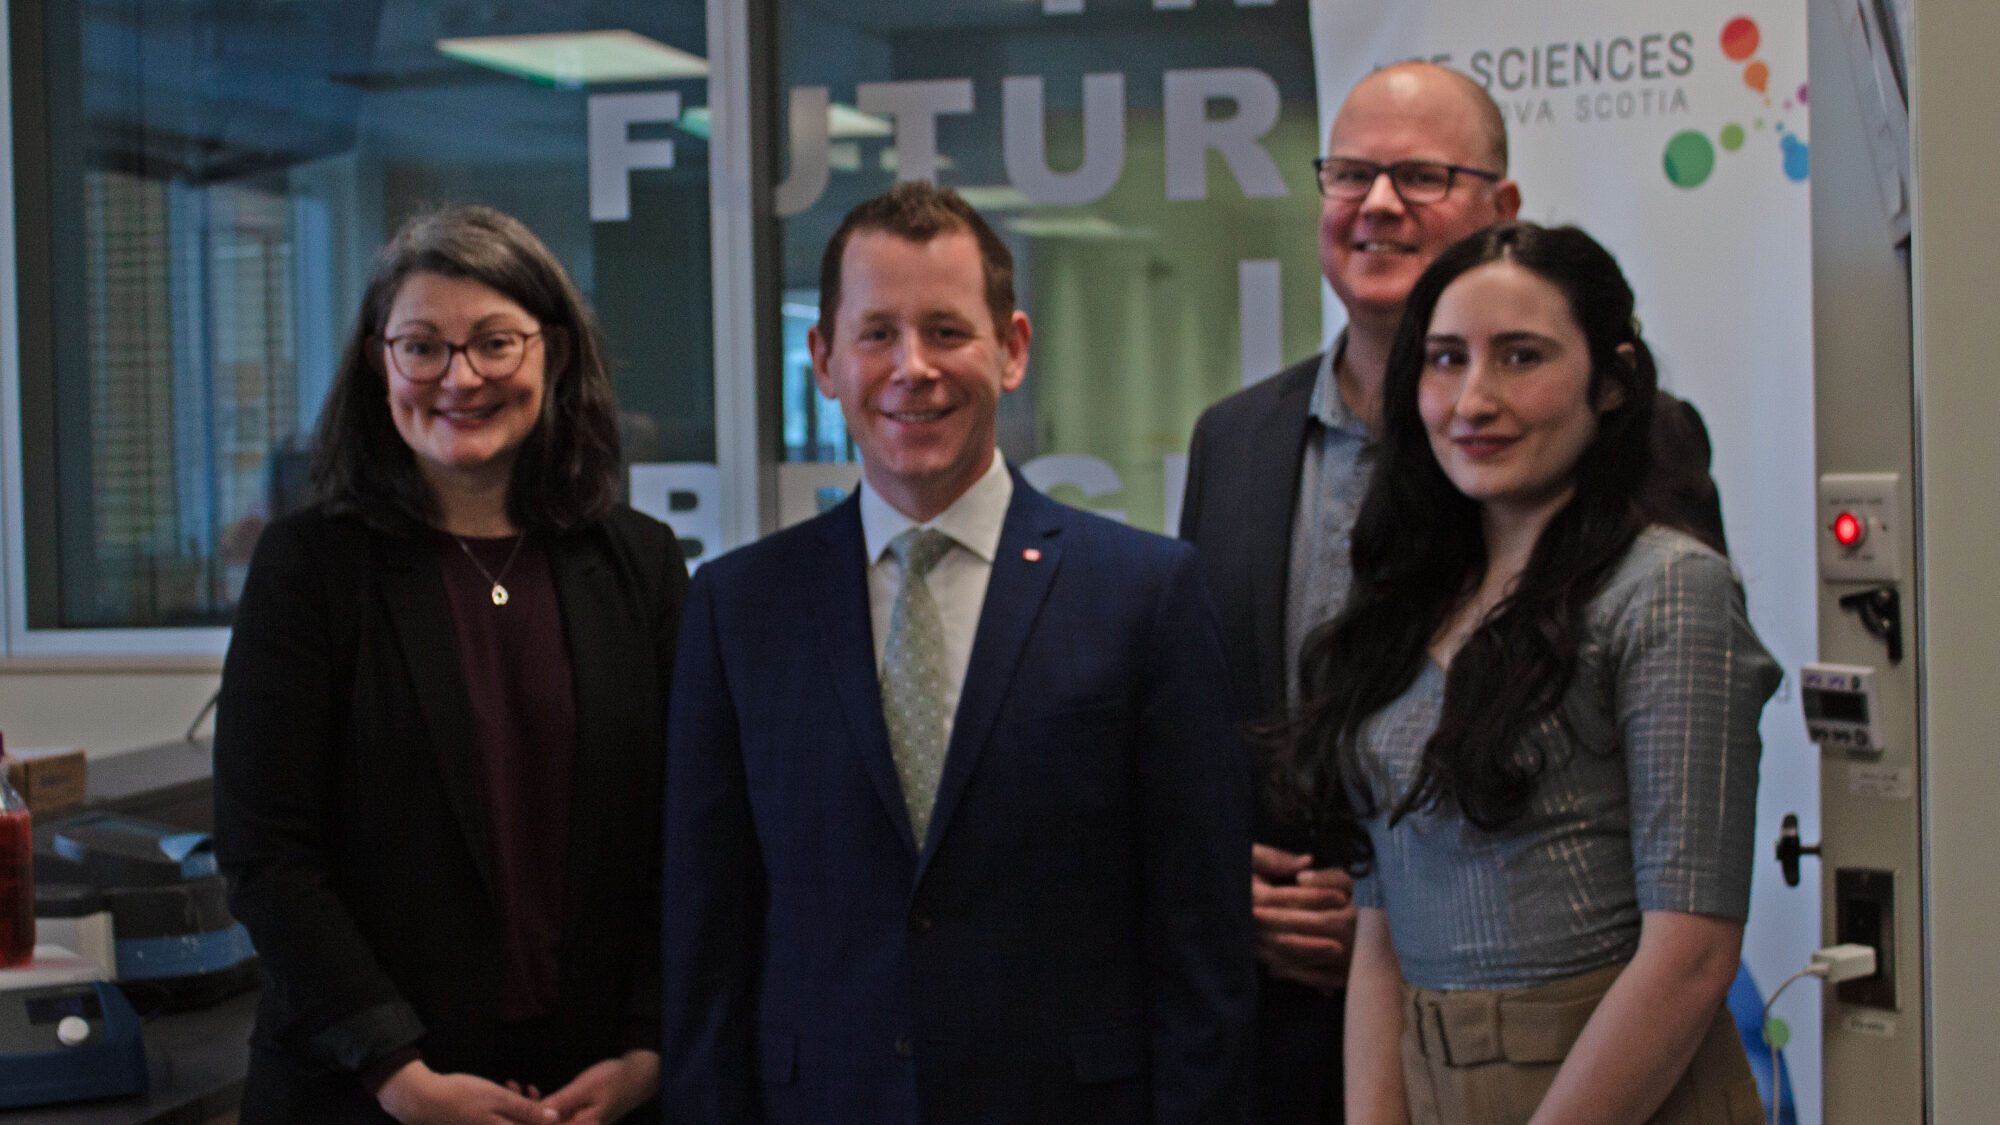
[8,0,716,629]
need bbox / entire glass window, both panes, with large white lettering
[8,0,1320,651]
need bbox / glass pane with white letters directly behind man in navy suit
[766,0,1320,530]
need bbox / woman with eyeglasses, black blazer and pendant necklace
[216,206,688,1125]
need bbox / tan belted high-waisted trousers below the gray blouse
[1402,952,1764,1125]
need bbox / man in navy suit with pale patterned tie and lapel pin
[662,184,1254,1125]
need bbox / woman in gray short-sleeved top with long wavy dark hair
[1276,222,1780,1125]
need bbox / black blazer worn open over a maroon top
[216,508,688,1123]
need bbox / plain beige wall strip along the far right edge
[1910,0,2000,1123]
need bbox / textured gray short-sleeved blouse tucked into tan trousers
[1356,526,1780,989]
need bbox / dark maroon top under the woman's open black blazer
[438,536,576,1021]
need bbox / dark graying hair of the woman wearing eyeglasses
[312,206,618,534]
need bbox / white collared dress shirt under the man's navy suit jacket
[862,450,1014,745]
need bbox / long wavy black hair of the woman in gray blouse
[1270,222,1658,869]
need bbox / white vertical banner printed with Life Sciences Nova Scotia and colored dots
[1312,0,1820,1125]
